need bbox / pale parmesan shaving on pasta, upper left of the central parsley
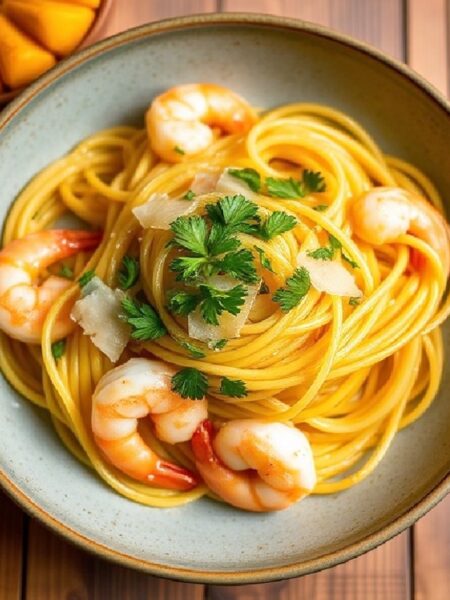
[132,194,197,229]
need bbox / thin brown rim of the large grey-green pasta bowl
[0,13,450,585]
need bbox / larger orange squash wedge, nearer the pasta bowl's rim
[3,0,95,56]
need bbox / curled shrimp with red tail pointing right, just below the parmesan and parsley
[92,358,207,490]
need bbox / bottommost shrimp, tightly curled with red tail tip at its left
[191,419,316,512]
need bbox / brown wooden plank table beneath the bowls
[0,0,450,600]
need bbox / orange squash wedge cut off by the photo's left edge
[0,13,56,88]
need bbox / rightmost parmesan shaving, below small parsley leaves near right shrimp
[297,252,362,298]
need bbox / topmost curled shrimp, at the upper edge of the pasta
[146,83,256,163]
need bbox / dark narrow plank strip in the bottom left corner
[0,492,26,600]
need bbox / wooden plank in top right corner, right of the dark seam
[407,0,449,94]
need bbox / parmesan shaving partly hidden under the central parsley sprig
[188,275,260,342]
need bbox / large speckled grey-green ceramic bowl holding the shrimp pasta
[0,14,450,584]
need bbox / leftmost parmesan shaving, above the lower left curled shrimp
[70,277,131,362]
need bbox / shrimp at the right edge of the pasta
[352,187,450,276]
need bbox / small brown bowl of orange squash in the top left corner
[0,0,112,107]
